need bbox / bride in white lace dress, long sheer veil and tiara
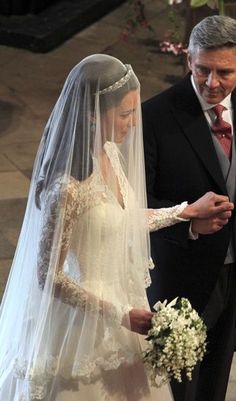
[0,55,232,401]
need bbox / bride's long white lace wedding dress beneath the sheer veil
[0,142,186,401]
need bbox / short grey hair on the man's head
[188,15,236,53]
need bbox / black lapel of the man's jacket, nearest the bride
[173,75,227,194]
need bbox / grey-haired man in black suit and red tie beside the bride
[143,16,236,401]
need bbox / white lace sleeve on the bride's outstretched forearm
[147,202,188,232]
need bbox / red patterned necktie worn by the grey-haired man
[211,104,232,159]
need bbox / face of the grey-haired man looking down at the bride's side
[188,46,236,104]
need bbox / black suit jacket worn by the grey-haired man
[142,74,236,312]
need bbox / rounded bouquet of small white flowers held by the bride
[143,298,206,387]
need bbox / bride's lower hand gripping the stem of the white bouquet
[122,308,153,334]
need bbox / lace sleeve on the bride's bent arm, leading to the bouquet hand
[37,180,127,326]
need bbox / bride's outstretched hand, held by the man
[179,192,234,219]
